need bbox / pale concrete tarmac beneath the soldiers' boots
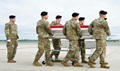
[0,42,120,71]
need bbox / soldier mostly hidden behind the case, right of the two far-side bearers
[78,17,87,63]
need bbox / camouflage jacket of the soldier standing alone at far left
[5,22,19,40]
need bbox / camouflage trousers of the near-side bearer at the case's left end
[35,38,50,61]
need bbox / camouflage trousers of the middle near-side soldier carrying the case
[63,40,79,62]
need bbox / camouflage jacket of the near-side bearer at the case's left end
[36,19,53,38]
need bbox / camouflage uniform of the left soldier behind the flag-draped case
[50,21,61,58]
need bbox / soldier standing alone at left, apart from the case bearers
[5,15,19,63]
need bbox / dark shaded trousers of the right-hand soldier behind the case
[78,39,86,60]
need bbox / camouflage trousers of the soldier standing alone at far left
[6,39,18,60]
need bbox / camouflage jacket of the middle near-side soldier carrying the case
[63,19,82,40]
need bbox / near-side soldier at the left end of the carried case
[33,11,53,66]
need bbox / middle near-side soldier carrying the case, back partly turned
[61,13,83,67]
